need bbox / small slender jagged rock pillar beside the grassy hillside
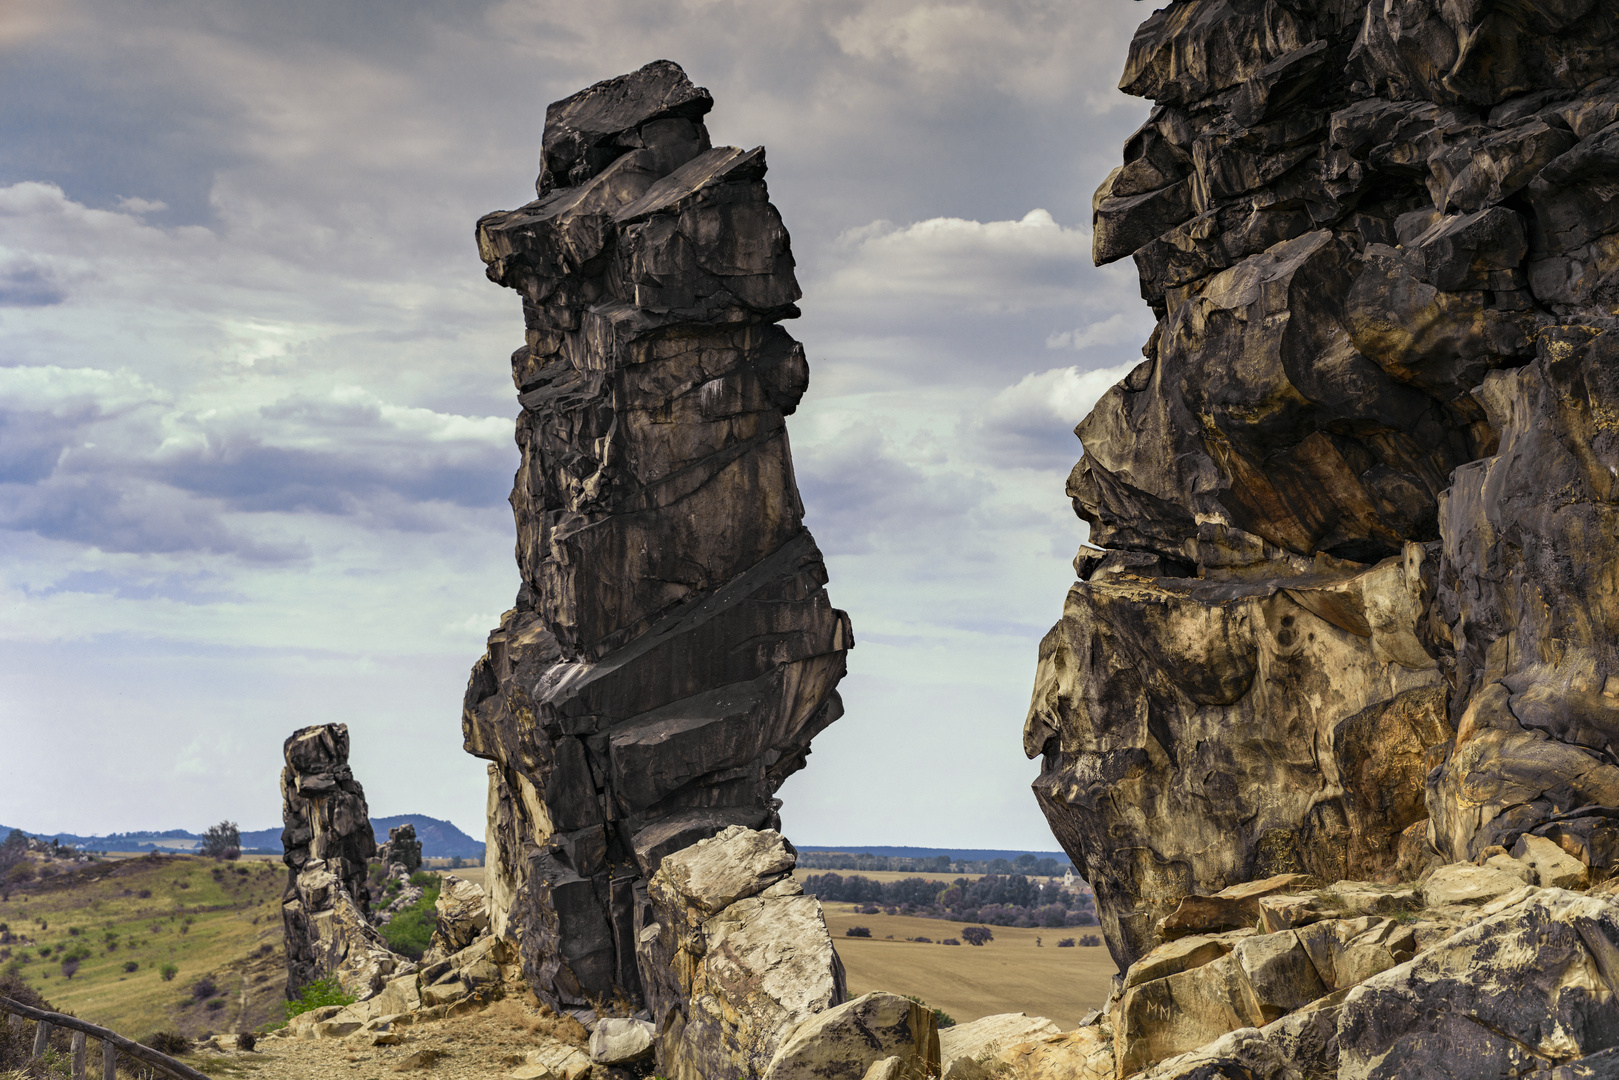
[282,724,405,997]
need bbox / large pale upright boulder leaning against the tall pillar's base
[638,826,848,1080]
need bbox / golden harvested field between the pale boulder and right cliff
[824,904,1117,1030]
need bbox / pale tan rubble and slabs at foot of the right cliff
[942,854,1619,1080]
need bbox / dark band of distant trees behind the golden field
[805,874,1096,926]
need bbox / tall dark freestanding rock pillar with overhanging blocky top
[463,62,853,1006]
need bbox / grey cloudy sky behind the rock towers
[0,0,1151,848]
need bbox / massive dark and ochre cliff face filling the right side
[1025,0,1619,963]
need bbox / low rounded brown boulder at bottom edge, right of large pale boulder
[763,993,939,1080]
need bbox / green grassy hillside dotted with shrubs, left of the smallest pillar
[0,855,287,1040]
